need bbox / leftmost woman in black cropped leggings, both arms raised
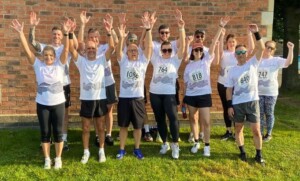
[11,19,71,169]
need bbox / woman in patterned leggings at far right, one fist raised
[258,41,294,142]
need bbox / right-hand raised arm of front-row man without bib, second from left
[103,14,115,61]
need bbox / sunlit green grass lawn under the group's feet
[0,93,300,180]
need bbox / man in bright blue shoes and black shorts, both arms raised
[116,13,152,159]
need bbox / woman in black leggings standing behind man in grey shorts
[217,29,254,140]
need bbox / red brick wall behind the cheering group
[0,0,270,115]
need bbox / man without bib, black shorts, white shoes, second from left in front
[69,19,114,164]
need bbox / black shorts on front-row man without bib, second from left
[80,99,107,118]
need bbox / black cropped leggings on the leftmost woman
[36,103,65,143]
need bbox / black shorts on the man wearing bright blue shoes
[118,98,147,129]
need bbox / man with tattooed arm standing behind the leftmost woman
[29,12,78,151]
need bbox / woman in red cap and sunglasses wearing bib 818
[183,17,229,156]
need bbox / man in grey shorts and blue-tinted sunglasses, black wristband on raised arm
[225,24,265,166]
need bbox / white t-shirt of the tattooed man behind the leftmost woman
[39,43,71,86]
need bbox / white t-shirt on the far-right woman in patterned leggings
[258,57,286,96]
